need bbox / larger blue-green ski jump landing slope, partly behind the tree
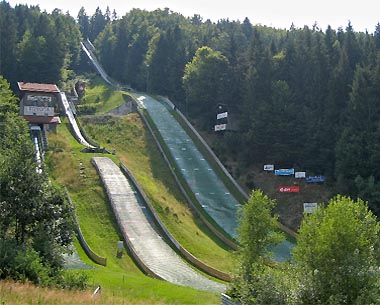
[134,94,294,262]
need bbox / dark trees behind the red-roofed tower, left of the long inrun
[0,1,82,87]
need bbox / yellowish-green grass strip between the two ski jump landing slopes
[83,114,233,272]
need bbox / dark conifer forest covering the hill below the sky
[0,1,380,215]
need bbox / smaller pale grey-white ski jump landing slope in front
[93,157,225,292]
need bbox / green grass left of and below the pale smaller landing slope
[47,120,223,304]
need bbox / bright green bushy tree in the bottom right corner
[294,196,380,305]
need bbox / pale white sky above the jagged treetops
[7,0,380,33]
